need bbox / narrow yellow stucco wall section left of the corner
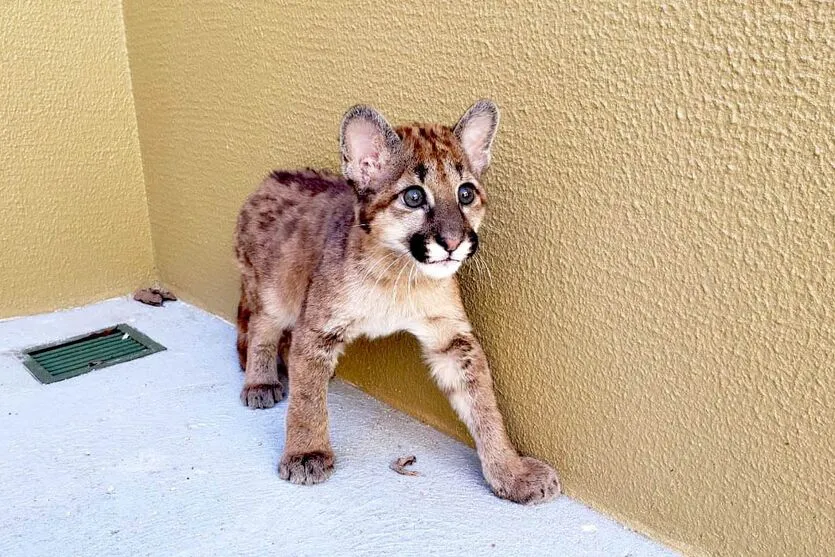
[0,0,153,317]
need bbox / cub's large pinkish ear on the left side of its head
[339,105,402,190]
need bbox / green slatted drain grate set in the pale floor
[22,324,165,383]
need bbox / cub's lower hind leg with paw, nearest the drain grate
[241,312,289,408]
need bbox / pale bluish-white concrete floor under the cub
[0,299,673,557]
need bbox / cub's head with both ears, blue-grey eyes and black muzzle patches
[340,100,499,278]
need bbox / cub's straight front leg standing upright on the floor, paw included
[278,326,345,485]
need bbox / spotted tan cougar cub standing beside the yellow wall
[236,100,560,503]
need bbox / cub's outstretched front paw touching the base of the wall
[491,456,561,505]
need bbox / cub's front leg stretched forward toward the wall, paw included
[416,319,560,504]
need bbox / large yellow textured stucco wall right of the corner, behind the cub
[125,0,835,555]
